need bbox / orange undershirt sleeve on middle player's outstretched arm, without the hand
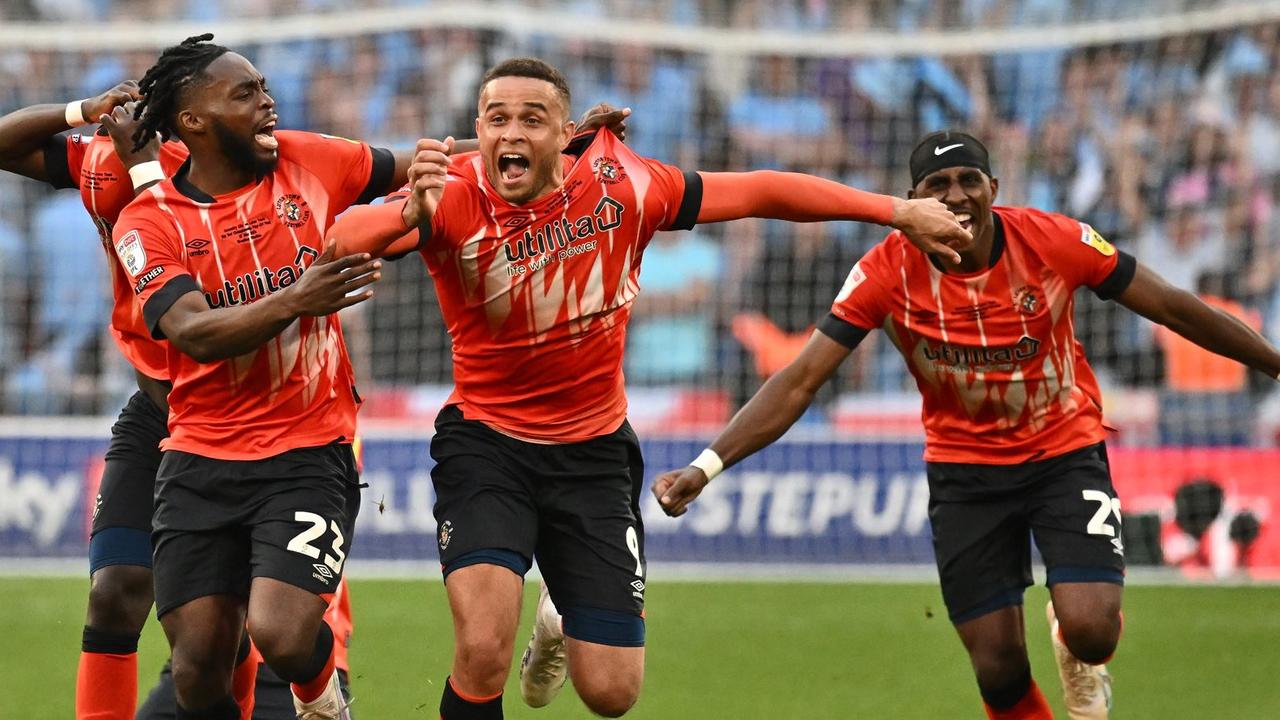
[698,170,897,225]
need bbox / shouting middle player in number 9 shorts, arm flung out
[330,58,968,720]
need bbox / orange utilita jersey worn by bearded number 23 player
[114,131,394,460]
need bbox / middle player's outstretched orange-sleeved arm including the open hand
[698,170,972,263]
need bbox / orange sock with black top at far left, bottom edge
[76,625,138,720]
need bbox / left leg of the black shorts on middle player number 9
[431,406,540,573]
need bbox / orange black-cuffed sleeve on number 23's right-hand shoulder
[287,132,396,215]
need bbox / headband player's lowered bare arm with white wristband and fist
[653,331,852,518]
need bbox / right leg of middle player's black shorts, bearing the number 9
[536,425,645,647]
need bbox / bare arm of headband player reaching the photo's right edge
[1116,263,1280,378]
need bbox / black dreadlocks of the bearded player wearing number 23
[133,32,228,152]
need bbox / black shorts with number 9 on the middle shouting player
[431,406,645,625]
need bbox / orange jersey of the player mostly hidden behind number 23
[45,133,187,380]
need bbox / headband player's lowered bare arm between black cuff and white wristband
[710,331,851,468]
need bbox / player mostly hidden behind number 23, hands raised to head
[0,81,371,720]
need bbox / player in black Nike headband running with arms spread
[653,132,1280,719]
